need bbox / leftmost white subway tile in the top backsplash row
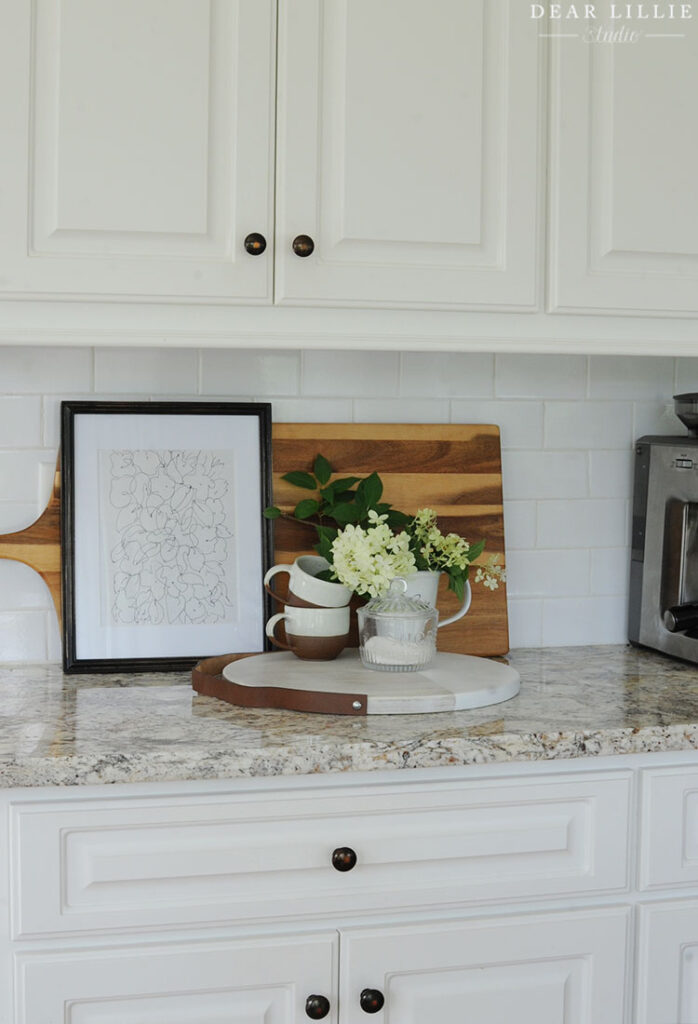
[0,345,92,394]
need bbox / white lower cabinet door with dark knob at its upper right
[13,934,338,1024]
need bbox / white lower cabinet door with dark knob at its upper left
[340,908,628,1024]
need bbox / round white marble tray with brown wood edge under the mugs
[192,650,520,716]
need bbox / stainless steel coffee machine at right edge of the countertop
[628,392,698,662]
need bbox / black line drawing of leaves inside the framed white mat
[100,449,235,626]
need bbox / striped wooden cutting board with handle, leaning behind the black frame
[0,423,509,655]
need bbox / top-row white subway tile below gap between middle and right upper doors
[494,355,586,398]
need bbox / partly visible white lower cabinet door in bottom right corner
[637,899,698,1024]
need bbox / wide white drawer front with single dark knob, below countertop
[11,772,629,937]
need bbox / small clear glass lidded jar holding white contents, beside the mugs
[357,577,439,672]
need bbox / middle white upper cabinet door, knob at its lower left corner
[276,0,540,309]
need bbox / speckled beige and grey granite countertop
[0,646,698,787]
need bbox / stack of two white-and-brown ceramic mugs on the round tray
[264,555,351,662]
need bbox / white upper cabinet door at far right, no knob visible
[549,25,698,316]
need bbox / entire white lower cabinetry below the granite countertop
[6,752,698,1024]
